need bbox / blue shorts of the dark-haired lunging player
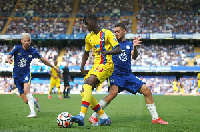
[109,74,145,94]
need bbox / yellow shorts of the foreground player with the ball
[84,63,114,85]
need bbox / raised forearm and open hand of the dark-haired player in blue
[131,36,142,60]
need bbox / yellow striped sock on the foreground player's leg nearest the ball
[80,84,92,117]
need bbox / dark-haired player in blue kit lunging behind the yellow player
[89,23,168,124]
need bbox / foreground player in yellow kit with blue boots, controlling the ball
[72,14,121,126]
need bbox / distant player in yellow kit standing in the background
[48,61,63,99]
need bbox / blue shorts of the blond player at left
[14,72,31,94]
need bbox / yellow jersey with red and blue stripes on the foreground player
[85,28,118,64]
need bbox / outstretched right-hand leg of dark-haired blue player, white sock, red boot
[139,84,168,124]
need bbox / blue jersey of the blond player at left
[9,45,42,78]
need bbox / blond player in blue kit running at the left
[8,33,60,118]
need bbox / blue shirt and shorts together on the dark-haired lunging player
[109,41,145,94]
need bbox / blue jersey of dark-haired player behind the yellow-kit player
[112,40,133,75]
